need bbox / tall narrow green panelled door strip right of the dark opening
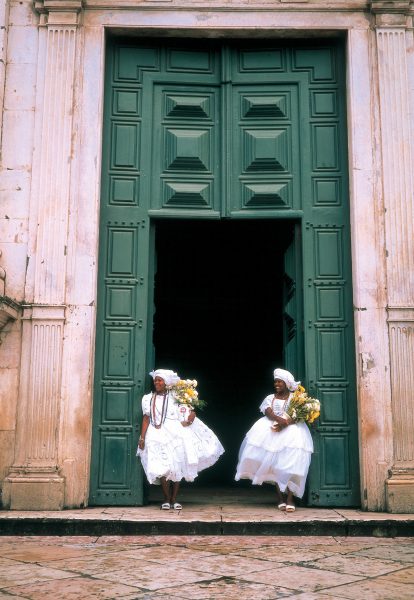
[300,45,360,506]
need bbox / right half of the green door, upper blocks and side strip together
[230,43,359,505]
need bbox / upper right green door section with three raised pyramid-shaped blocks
[228,82,300,218]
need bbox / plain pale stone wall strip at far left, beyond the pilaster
[0,1,38,506]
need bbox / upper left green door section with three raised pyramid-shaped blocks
[148,82,221,217]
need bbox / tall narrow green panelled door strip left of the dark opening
[90,42,157,505]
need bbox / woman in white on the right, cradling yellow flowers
[236,369,313,512]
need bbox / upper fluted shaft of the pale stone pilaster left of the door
[34,25,76,304]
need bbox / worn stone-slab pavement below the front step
[0,536,414,600]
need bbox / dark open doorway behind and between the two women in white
[153,220,294,486]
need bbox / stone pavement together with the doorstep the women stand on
[0,487,414,600]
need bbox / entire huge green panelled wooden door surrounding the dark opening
[91,41,359,506]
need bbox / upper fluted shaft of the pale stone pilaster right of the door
[377,29,414,307]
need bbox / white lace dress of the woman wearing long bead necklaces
[137,393,224,484]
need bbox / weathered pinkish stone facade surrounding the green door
[0,0,414,512]
